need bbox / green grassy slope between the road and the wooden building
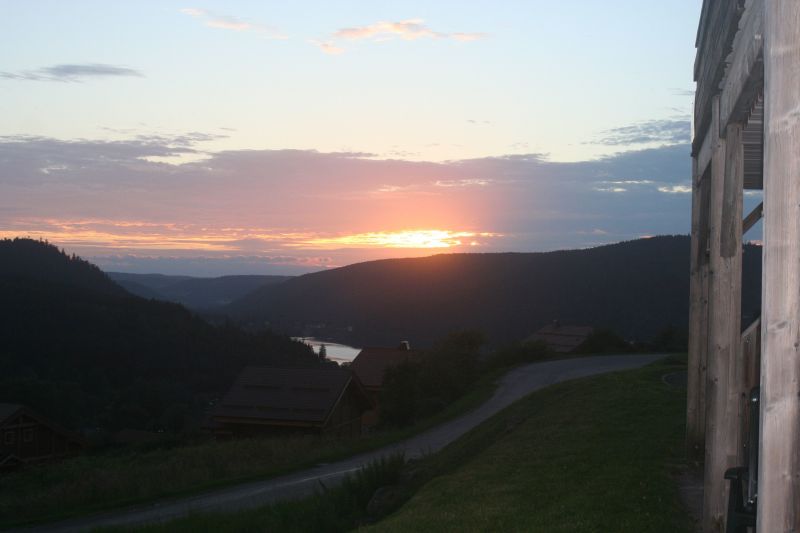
[106,357,692,533]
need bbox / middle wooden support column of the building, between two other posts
[703,98,744,533]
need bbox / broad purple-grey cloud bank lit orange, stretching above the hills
[0,132,700,273]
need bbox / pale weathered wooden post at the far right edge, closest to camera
[757,0,800,533]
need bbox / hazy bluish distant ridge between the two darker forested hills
[107,272,291,311]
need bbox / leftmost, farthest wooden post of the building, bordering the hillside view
[686,158,711,465]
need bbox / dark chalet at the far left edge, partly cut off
[0,403,86,469]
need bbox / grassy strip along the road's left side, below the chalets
[0,364,503,528]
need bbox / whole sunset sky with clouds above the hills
[0,0,736,276]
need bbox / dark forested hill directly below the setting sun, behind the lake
[228,236,761,345]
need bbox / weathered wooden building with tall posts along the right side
[687,0,800,533]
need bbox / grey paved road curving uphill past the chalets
[26,355,662,532]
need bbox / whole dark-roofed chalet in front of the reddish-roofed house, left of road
[208,367,372,437]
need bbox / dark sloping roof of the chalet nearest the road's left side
[212,367,360,425]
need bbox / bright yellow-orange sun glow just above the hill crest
[303,230,500,249]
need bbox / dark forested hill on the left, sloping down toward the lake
[0,239,319,430]
